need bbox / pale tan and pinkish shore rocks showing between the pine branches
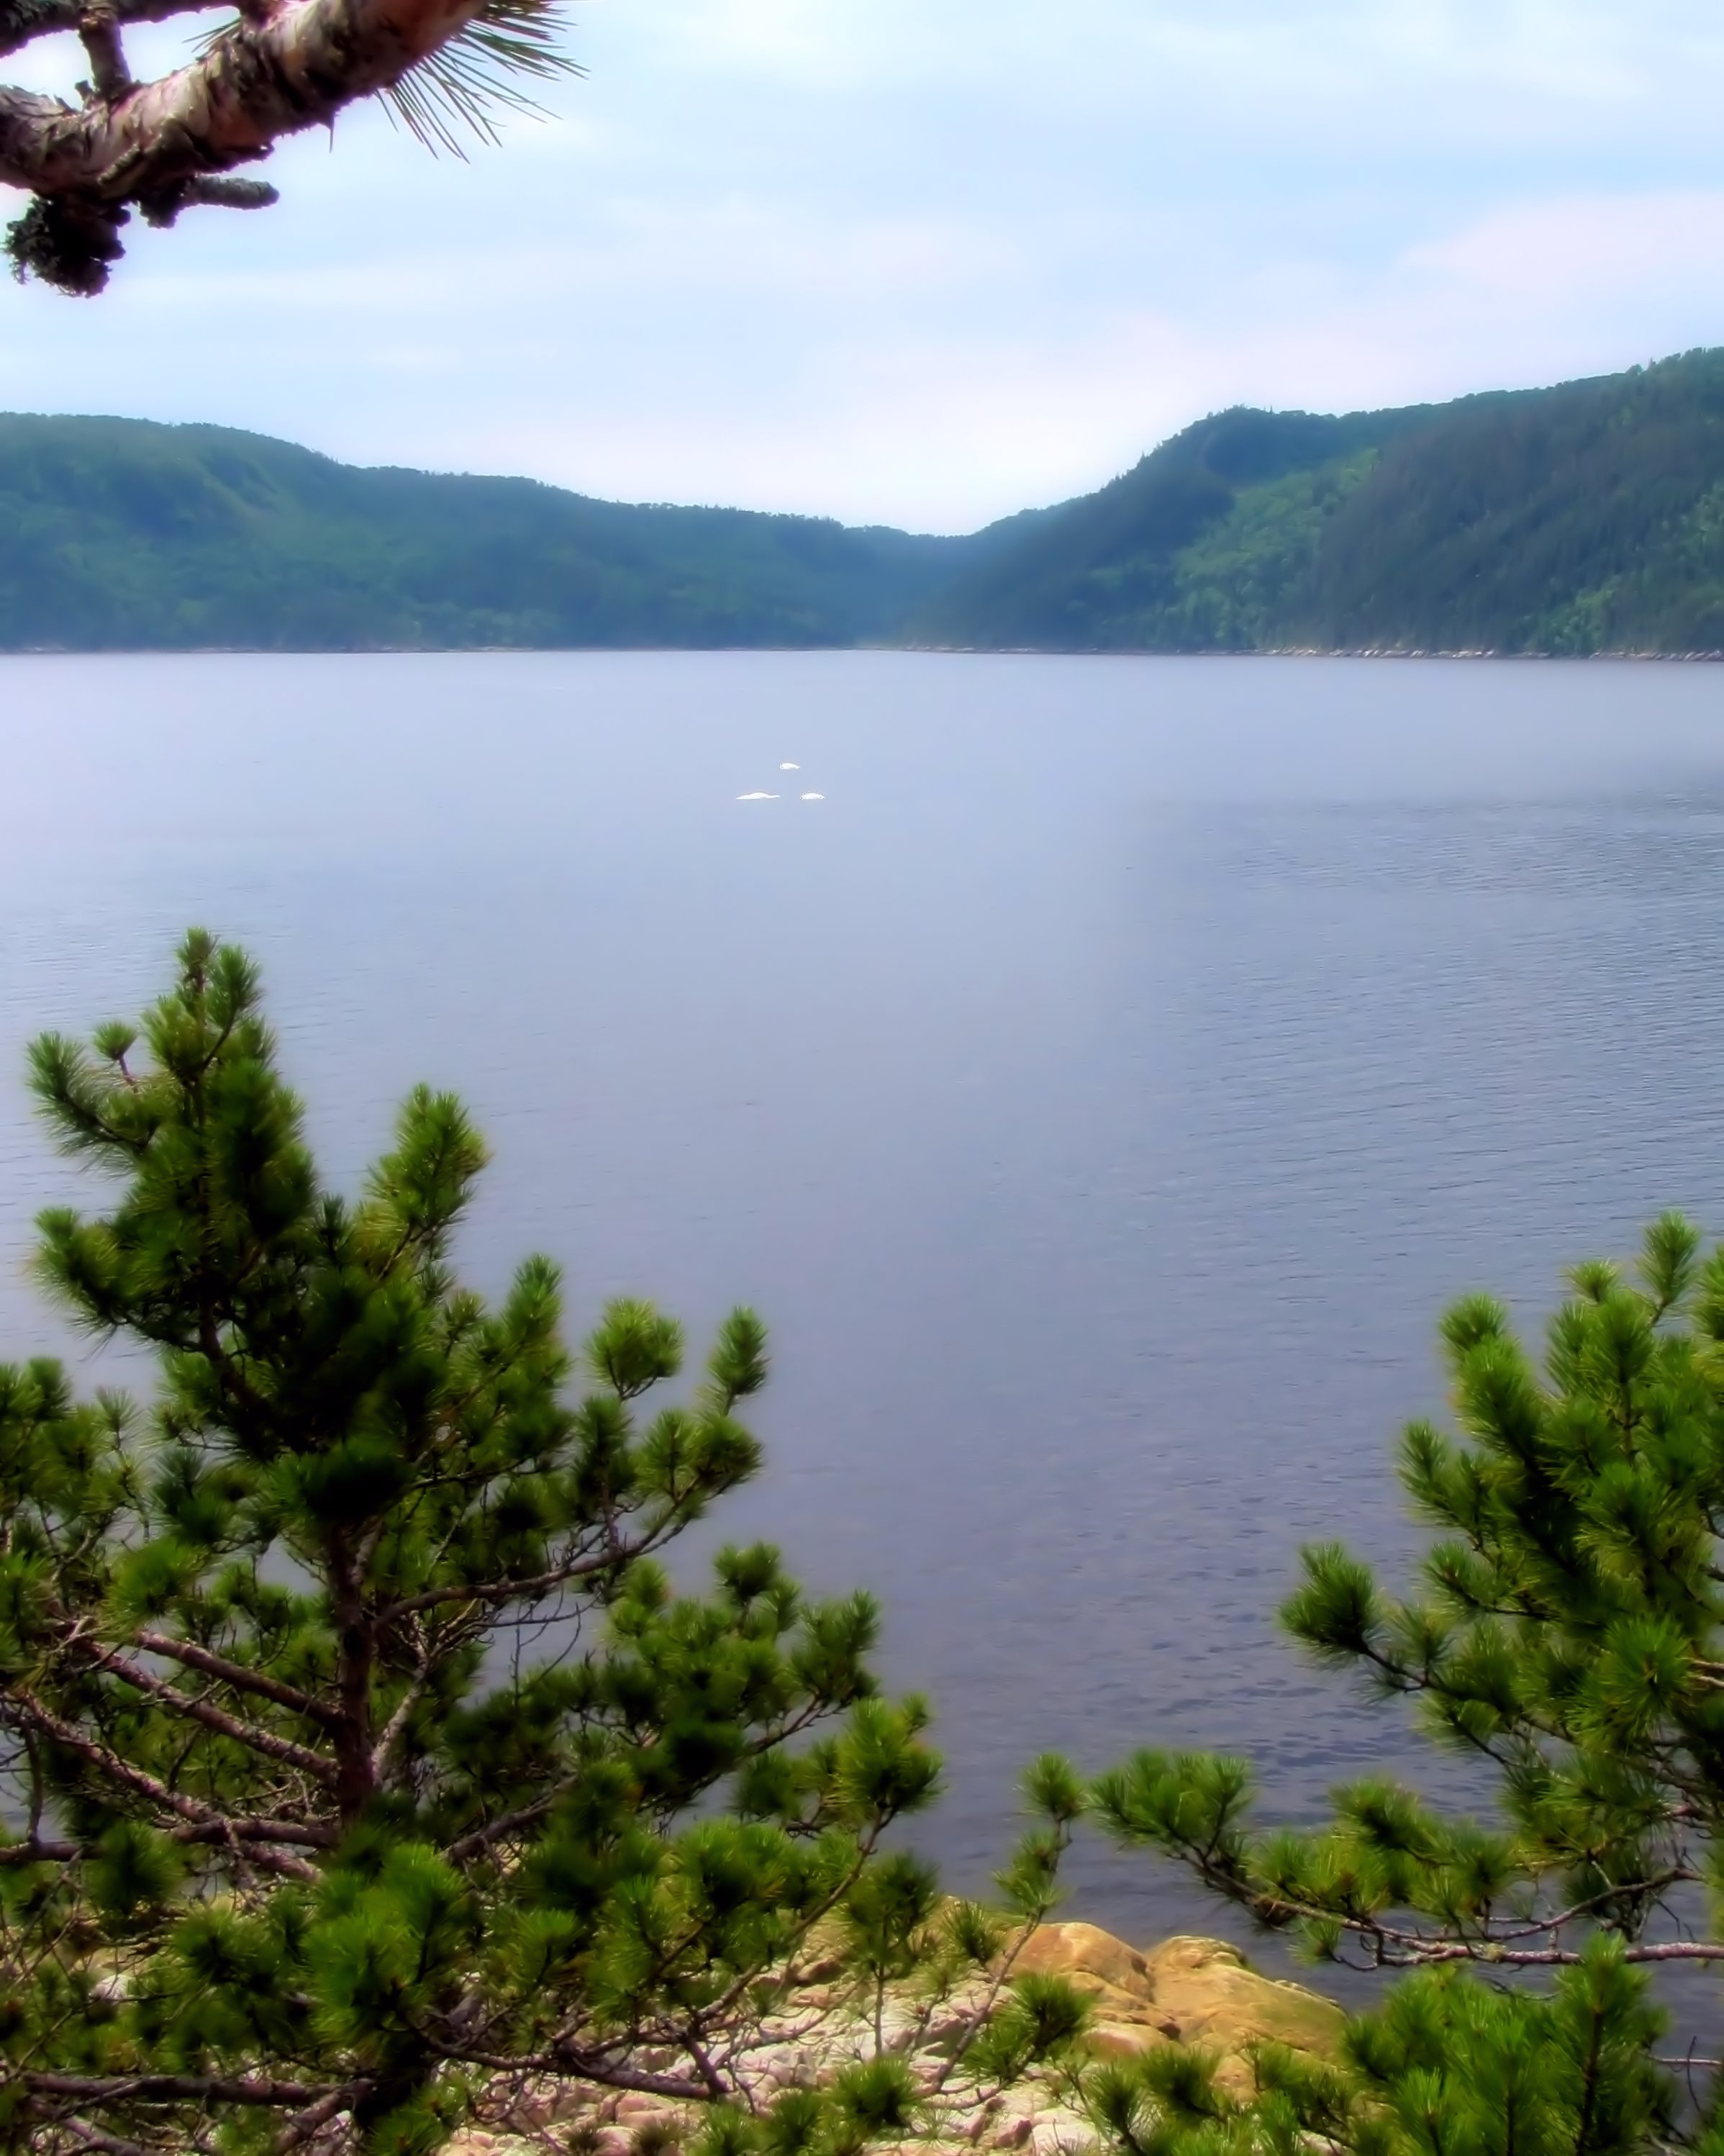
[450,1923,1345,2156]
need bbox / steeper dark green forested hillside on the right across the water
[914,351,1724,653]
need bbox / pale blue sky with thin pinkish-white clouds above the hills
[0,0,1724,530]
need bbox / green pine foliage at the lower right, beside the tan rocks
[1090,1214,1724,2156]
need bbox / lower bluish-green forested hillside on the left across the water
[0,414,1038,651]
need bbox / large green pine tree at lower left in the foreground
[0,933,1078,2156]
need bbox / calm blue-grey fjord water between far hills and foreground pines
[0,653,1724,1936]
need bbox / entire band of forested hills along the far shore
[0,351,1724,653]
